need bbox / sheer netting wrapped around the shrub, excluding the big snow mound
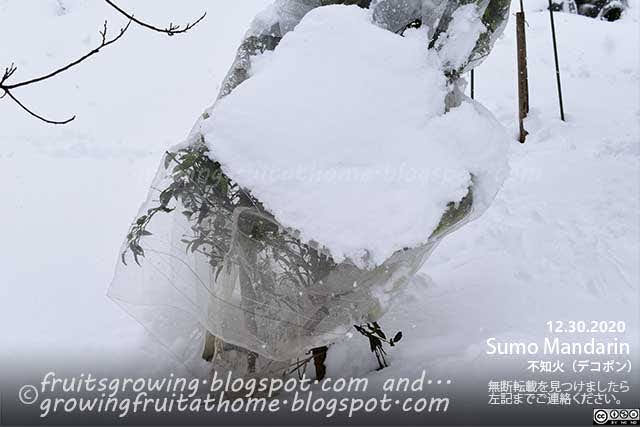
[108,0,509,375]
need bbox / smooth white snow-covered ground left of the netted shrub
[0,0,269,374]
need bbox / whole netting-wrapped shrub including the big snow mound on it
[110,0,510,382]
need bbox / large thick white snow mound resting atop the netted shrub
[202,6,510,264]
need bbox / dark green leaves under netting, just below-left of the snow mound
[122,143,336,295]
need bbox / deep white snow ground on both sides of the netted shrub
[0,0,640,392]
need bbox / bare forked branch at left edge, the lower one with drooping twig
[0,21,131,125]
